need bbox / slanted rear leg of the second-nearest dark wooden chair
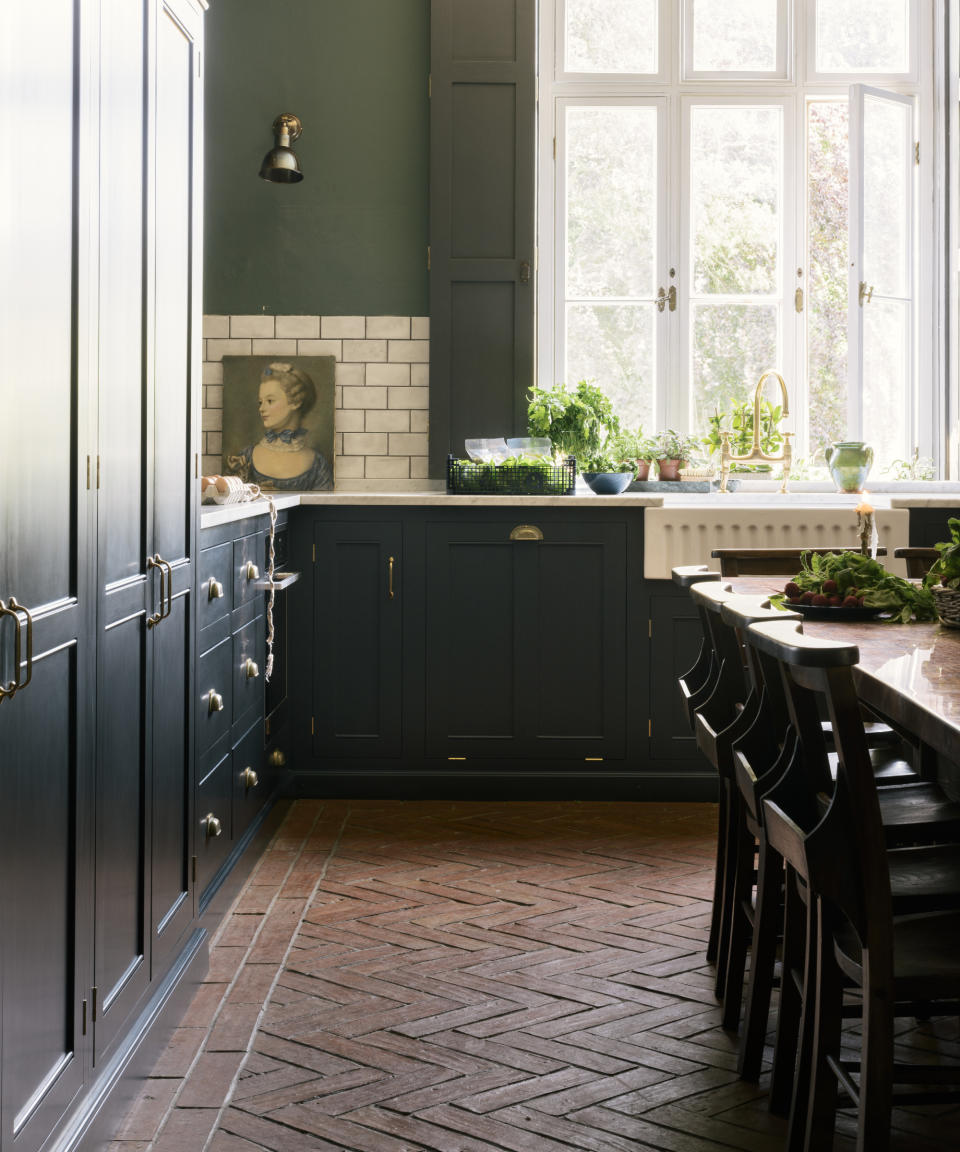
[738,840,784,1082]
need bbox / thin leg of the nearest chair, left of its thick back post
[795,900,844,1152]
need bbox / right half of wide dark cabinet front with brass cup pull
[517,523,627,759]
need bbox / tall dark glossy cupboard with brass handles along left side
[0,0,206,1152]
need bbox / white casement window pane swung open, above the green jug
[847,84,917,461]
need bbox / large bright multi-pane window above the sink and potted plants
[539,0,933,464]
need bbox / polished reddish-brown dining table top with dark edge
[725,576,960,771]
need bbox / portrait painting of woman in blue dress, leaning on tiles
[224,357,333,492]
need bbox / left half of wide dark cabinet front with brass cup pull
[426,523,524,757]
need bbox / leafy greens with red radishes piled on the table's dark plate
[770,552,935,624]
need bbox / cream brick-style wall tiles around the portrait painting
[202,314,430,490]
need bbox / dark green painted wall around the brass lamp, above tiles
[204,0,430,316]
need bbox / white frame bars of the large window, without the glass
[537,0,960,475]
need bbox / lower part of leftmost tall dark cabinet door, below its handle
[0,644,85,1150]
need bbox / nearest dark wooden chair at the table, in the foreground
[747,621,960,1152]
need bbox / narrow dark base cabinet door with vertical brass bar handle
[313,523,403,757]
